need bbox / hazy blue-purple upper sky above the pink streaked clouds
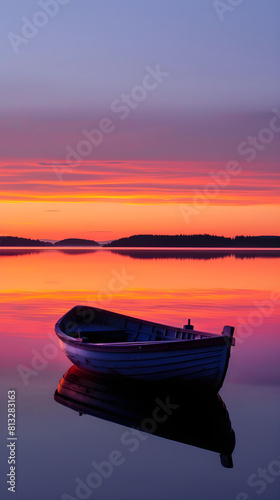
[0,0,280,161]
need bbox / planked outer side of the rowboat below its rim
[56,339,228,389]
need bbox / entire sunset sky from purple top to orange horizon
[0,0,280,241]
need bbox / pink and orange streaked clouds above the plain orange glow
[0,161,280,203]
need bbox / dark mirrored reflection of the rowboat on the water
[54,365,235,468]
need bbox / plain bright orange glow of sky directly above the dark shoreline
[0,202,280,241]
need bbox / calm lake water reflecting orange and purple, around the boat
[0,249,280,500]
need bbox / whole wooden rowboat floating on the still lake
[55,306,234,391]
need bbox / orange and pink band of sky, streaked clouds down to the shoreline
[0,160,280,241]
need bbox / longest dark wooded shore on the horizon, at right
[103,234,280,248]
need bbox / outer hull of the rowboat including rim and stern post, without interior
[56,304,233,390]
